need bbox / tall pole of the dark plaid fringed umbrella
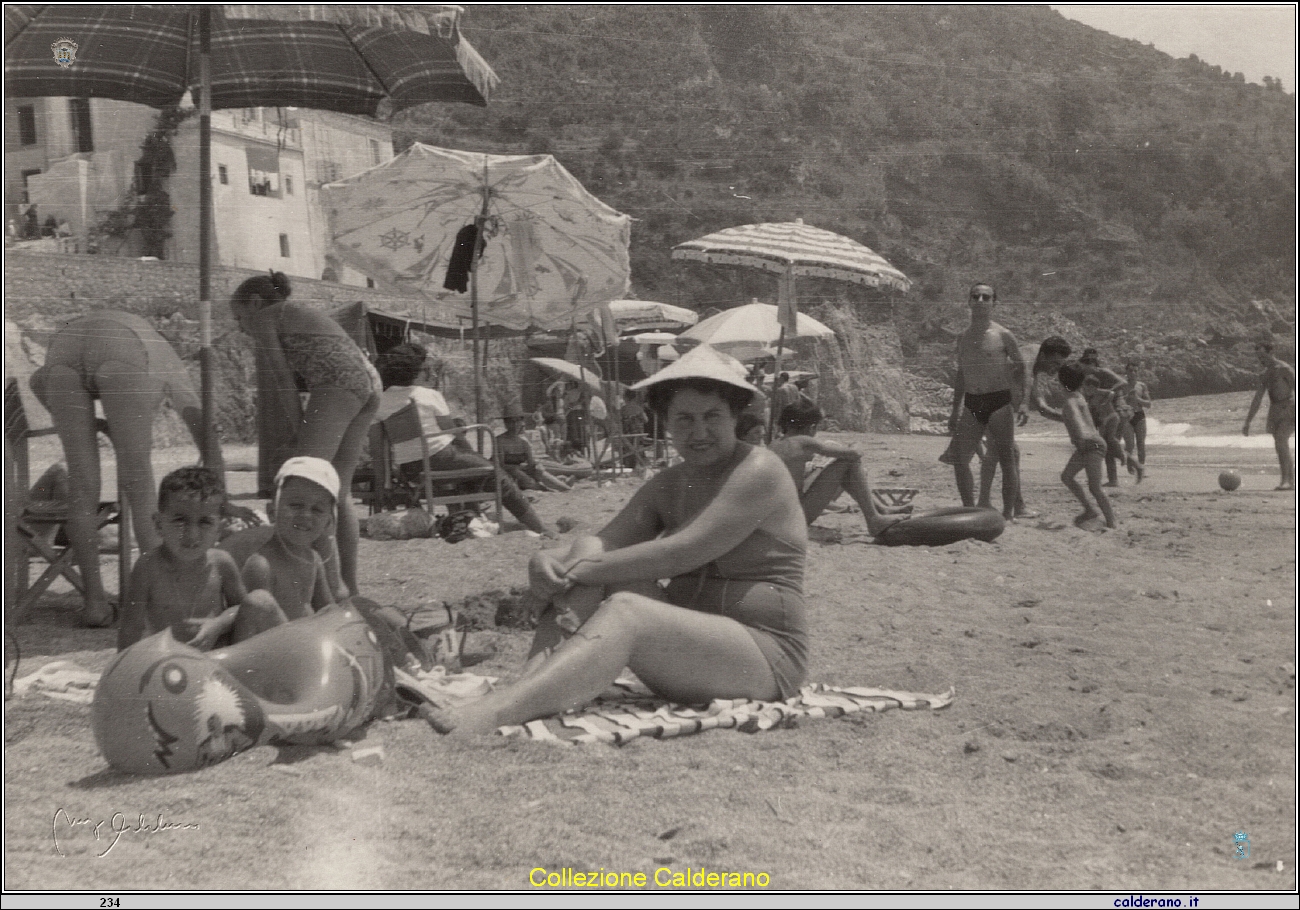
[199,4,217,465]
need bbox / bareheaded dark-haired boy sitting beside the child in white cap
[117,467,248,650]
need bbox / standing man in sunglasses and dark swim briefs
[945,282,1028,520]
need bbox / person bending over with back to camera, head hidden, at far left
[31,309,224,625]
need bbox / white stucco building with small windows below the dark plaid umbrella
[5,98,393,286]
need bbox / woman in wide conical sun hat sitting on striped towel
[428,345,807,733]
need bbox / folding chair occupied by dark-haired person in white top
[371,404,502,524]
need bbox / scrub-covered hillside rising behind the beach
[397,5,1295,424]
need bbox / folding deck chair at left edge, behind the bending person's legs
[5,380,131,623]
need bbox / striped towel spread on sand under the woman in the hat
[497,675,957,745]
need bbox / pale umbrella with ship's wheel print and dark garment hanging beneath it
[321,143,632,329]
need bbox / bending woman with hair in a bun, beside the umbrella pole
[230,272,381,597]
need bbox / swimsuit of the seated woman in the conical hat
[666,520,809,698]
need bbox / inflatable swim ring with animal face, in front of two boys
[91,608,393,774]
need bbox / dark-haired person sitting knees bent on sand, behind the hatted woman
[768,400,910,537]
